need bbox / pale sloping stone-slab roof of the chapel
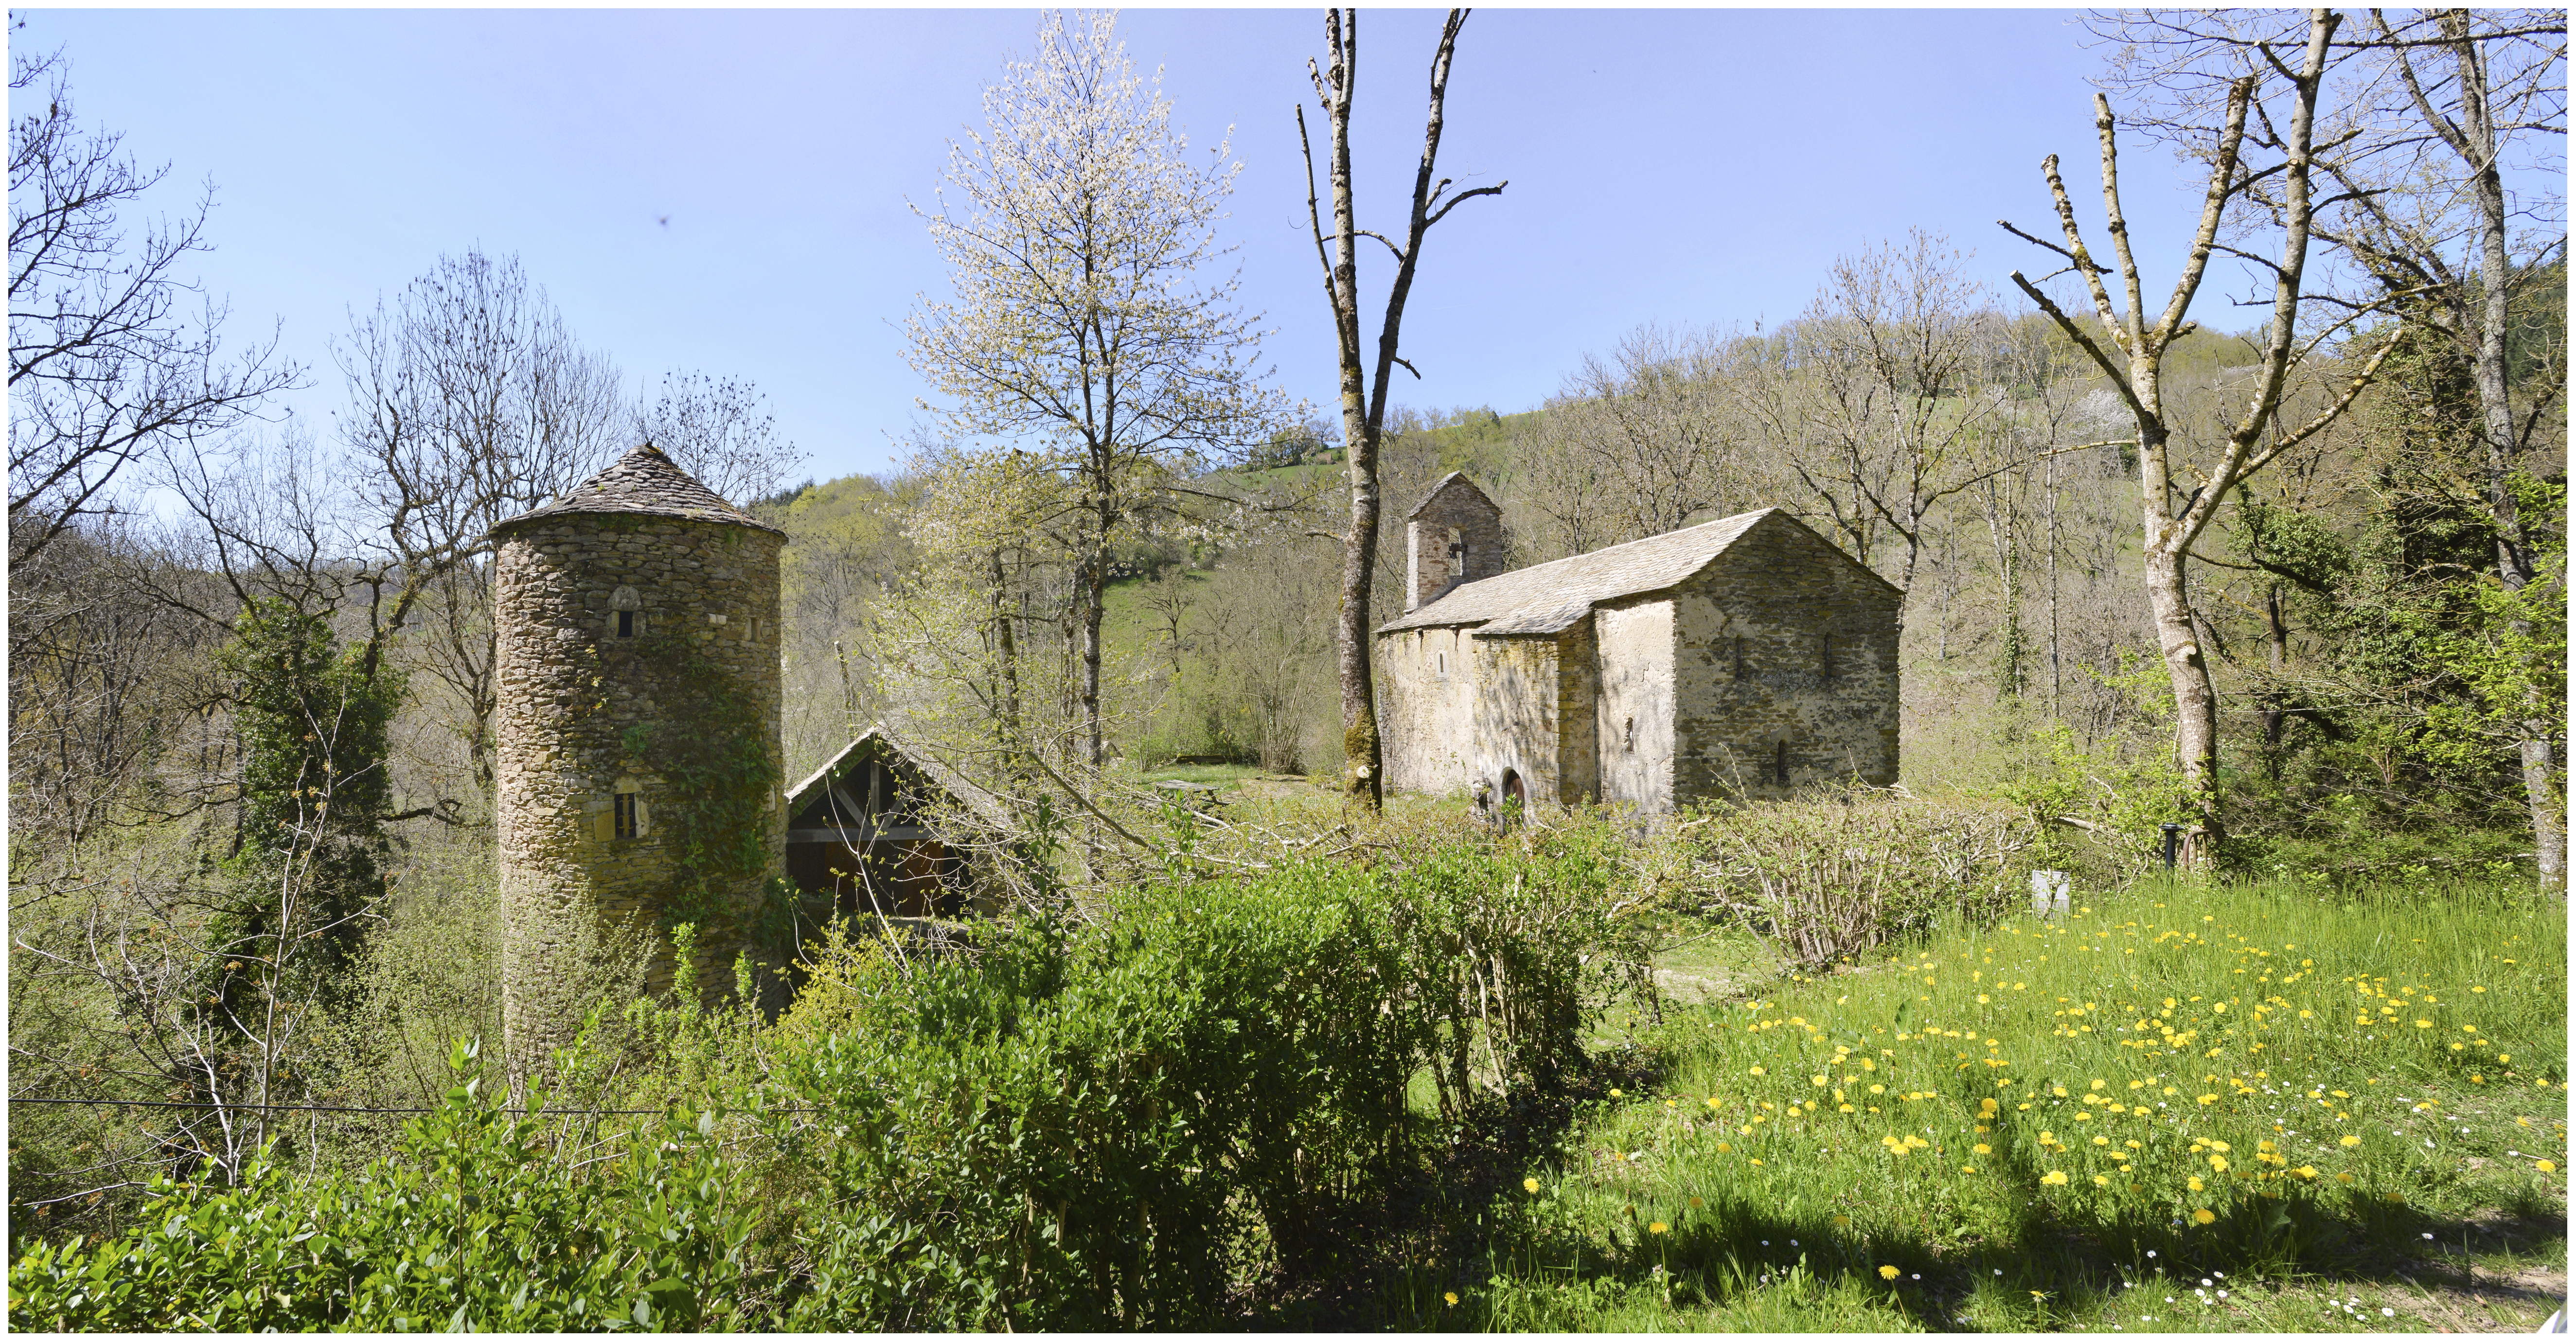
[1378,508,1788,636]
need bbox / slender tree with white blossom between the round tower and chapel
[907,13,1285,770]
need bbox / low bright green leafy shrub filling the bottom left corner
[8,1043,760,1332]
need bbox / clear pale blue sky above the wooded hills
[10,10,2241,479]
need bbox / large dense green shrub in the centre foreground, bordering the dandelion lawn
[775,837,1623,1329]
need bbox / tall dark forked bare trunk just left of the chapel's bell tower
[1296,10,1512,806]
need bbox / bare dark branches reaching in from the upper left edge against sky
[8,44,304,569]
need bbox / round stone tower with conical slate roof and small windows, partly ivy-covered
[492,443,786,1074]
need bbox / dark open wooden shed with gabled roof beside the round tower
[788,724,995,917]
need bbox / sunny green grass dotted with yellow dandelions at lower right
[1421,886,2566,1332]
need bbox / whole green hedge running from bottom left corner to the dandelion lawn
[10,830,1643,1329]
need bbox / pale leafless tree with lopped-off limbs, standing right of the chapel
[2004,10,2393,865]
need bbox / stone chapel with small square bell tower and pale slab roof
[1376,474,1901,812]
